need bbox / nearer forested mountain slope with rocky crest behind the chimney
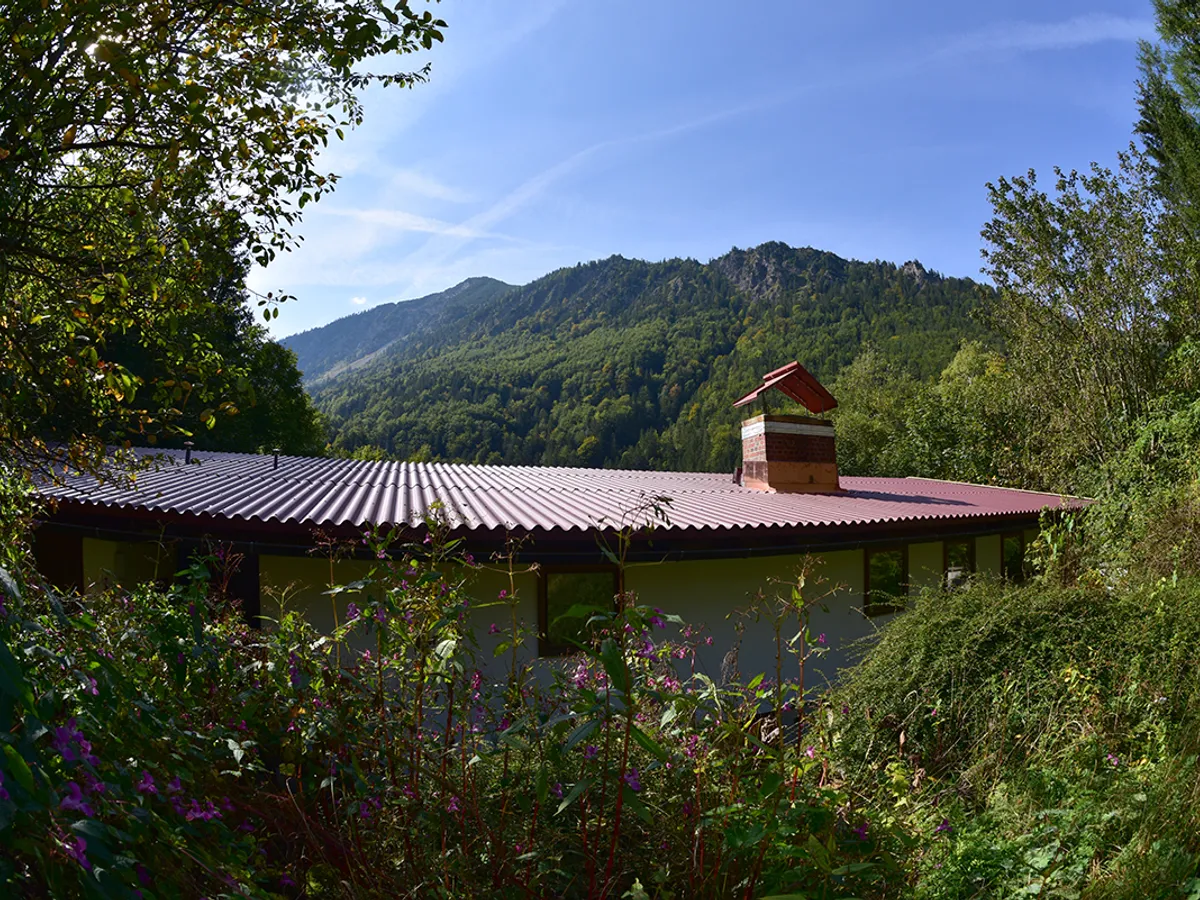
[313,244,984,470]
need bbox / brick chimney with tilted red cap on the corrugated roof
[733,362,841,493]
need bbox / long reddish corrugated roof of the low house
[42,449,1079,532]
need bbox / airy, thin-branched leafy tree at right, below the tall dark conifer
[983,149,1200,490]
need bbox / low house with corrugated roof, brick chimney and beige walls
[36,362,1081,678]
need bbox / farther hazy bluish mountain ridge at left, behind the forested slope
[281,278,512,386]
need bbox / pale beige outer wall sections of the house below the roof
[83,535,1028,685]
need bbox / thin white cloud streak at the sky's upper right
[937,14,1154,56]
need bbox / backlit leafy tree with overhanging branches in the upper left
[0,0,444,475]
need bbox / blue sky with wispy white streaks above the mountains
[250,0,1154,337]
